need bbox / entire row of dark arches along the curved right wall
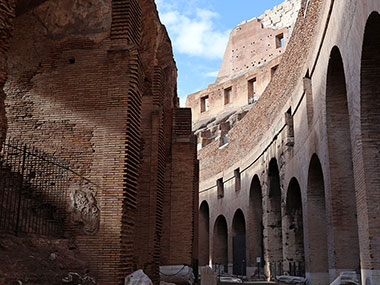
[200,12,380,276]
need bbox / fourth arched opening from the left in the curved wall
[247,175,264,278]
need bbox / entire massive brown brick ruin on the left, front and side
[0,0,198,284]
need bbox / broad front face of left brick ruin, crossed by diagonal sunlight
[4,0,132,284]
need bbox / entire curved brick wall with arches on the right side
[194,0,380,284]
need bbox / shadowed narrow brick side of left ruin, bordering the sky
[135,0,198,276]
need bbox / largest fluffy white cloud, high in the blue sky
[157,0,230,59]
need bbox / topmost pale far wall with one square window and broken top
[216,0,301,79]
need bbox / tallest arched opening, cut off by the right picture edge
[357,12,380,276]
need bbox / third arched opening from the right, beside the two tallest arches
[306,154,329,284]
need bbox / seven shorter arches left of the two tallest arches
[199,154,342,275]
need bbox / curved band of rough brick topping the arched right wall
[198,0,321,181]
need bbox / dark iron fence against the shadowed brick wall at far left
[0,139,70,237]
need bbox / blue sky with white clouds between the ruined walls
[156,0,284,107]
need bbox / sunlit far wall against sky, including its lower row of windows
[186,0,301,122]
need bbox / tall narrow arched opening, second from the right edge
[326,47,360,272]
